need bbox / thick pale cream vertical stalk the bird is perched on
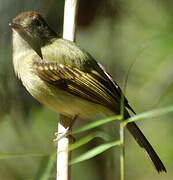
[57,0,78,180]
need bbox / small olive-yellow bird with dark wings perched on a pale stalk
[10,11,166,172]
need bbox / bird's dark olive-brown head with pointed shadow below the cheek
[9,11,57,56]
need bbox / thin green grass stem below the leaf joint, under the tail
[120,123,125,180]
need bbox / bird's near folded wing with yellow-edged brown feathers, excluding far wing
[34,61,119,111]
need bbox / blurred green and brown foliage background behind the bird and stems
[0,0,173,180]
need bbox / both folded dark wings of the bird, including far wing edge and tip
[34,57,135,113]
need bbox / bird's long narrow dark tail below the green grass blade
[126,122,166,173]
